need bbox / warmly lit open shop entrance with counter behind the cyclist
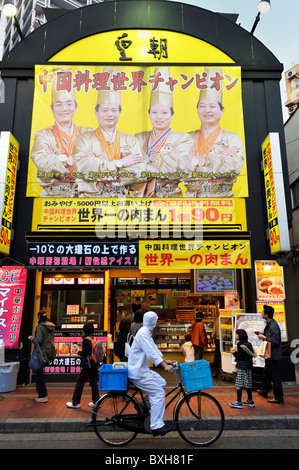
[110,270,244,363]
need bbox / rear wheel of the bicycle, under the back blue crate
[91,392,141,447]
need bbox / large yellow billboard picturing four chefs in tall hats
[26,64,248,199]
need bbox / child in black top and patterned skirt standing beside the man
[229,329,256,408]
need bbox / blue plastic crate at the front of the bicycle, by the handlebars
[180,359,213,392]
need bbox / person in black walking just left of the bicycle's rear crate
[66,323,100,408]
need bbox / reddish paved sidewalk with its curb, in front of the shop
[0,381,299,439]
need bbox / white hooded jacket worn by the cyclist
[128,312,163,379]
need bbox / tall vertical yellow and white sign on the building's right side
[262,132,290,254]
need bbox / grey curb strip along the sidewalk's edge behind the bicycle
[0,415,299,434]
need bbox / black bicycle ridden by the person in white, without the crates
[90,363,225,447]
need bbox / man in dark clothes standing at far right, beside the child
[256,305,284,403]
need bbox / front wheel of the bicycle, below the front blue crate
[175,391,224,447]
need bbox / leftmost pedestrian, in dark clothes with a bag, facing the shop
[28,310,55,403]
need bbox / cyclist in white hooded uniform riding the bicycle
[128,312,174,436]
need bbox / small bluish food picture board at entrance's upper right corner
[195,269,235,292]
